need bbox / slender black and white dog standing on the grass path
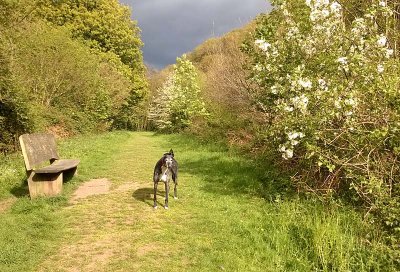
[153,149,178,209]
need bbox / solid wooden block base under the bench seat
[27,171,63,198]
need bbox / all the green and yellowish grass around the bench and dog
[0,132,396,271]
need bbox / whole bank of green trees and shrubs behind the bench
[0,0,147,151]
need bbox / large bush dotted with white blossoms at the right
[248,0,393,163]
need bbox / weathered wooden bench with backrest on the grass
[19,133,79,198]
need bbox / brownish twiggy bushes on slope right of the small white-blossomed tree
[189,25,260,148]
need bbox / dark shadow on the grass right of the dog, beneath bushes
[162,136,293,200]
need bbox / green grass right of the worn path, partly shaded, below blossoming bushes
[157,136,396,271]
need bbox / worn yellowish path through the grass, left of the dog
[38,133,185,272]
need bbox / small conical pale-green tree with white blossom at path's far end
[149,55,206,131]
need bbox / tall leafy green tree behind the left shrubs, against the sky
[32,0,147,129]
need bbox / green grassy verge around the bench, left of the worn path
[0,132,135,271]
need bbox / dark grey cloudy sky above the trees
[120,0,271,69]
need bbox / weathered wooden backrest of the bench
[19,133,59,170]
